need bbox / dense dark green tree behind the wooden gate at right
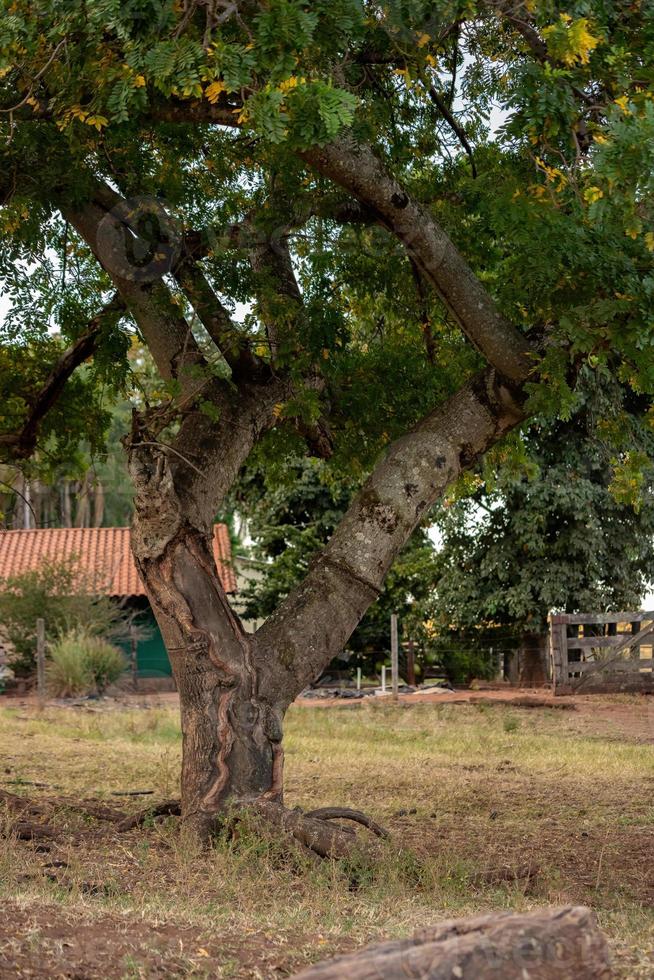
[433,378,654,682]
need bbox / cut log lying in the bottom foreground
[295,906,611,980]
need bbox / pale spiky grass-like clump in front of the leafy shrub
[46,629,127,698]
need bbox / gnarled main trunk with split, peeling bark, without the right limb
[132,444,283,837]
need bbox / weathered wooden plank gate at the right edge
[550,612,654,694]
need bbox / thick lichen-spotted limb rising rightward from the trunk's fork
[257,369,524,709]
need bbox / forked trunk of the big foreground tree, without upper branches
[129,370,523,835]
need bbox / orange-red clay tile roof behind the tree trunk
[0,524,236,596]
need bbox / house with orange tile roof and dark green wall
[0,524,236,683]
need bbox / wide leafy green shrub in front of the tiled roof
[0,557,125,676]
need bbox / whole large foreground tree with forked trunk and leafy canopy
[0,0,654,833]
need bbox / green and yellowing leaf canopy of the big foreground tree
[0,0,654,484]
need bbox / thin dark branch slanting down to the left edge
[0,296,124,460]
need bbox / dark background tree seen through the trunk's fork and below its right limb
[236,458,436,673]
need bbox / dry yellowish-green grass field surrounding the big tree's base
[0,703,654,980]
